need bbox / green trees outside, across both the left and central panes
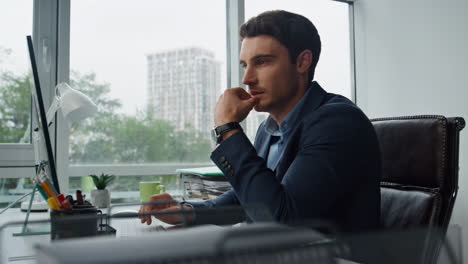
[0,56,211,163]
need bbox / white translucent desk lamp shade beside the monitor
[56,83,97,122]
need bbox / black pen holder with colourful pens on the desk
[50,205,102,240]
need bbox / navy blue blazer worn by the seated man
[192,82,381,231]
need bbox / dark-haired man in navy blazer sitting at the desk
[140,11,381,231]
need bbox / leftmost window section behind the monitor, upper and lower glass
[0,0,51,207]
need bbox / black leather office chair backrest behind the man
[371,115,465,263]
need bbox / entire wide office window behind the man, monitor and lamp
[0,0,351,206]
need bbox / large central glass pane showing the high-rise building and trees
[70,0,226,165]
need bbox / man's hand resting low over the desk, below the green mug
[138,193,193,225]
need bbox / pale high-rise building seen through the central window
[146,47,221,138]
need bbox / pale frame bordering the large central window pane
[56,0,232,192]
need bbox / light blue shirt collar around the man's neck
[265,84,312,137]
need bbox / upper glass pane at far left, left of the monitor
[0,0,33,143]
